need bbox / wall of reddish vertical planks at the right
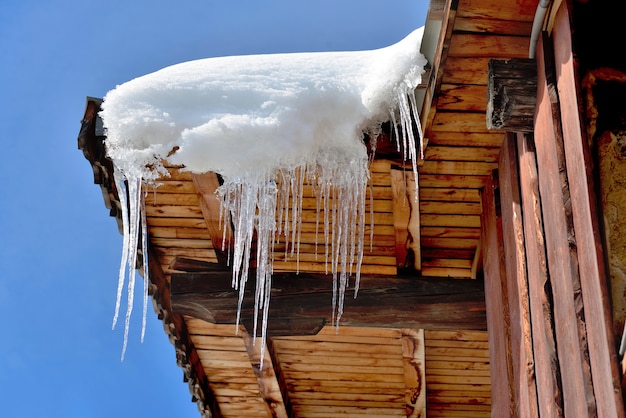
[483,2,624,417]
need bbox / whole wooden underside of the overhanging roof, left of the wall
[79,0,537,417]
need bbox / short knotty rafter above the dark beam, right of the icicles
[390,169,422,271]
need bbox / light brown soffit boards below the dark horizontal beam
[185,317,491,418]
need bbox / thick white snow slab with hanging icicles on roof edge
[100,28,426,360]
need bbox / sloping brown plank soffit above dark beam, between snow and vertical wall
[419,0,536,278]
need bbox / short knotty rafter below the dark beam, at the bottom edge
[402,329,426,418]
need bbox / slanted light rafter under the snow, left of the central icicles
[191,172,233,266]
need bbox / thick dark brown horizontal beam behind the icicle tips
[171,263,486,335]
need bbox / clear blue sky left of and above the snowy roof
[0,0,427,418]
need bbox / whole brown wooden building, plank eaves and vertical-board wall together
[79,0,626,417]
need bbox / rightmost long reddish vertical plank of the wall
[552,3,625,417]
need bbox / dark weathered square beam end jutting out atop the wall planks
[486,58,537,132]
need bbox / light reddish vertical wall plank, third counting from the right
[517,133,563,417]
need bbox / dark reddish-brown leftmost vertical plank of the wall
[482,171,517,417]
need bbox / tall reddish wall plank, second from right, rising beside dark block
[535,33,596,416]
